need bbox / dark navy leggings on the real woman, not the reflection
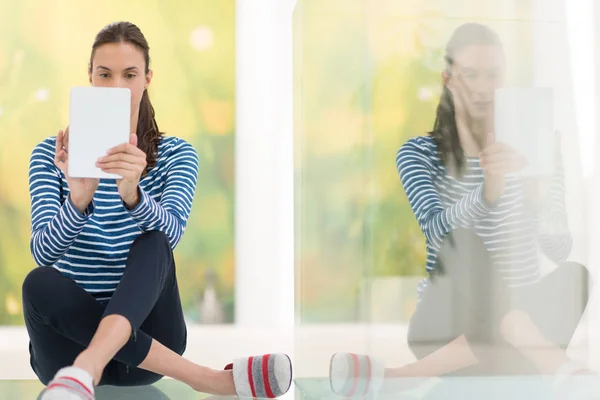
[23,231,187,386]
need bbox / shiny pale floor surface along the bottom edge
[0,376,600,400]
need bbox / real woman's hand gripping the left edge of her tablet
[54,126,100,213]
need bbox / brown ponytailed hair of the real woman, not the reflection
[89,22,164,175]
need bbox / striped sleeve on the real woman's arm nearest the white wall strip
[129,139,199,249]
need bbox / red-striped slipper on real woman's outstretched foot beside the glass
[225,354,292,399]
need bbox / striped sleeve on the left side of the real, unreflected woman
[29,140,94,266]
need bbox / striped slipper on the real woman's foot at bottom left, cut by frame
[38,367,95,400]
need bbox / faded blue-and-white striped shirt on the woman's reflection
[396,136,572,292]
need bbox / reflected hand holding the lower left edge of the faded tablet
[479,142,527,204]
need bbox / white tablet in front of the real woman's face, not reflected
[69,87,131,179]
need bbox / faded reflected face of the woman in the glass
[450,45,505,120]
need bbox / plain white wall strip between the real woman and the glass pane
[235,0,296,331]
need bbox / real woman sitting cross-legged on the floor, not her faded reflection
[23,22,291,400]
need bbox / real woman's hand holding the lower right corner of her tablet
[96,133,147,209]
